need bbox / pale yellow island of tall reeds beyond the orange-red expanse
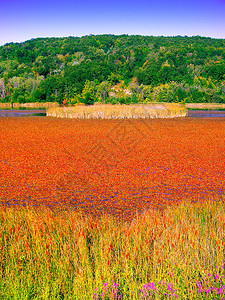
[47,103,186,119]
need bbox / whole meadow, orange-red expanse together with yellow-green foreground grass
[0,117,225,299]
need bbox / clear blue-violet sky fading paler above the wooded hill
[0,0,225,45]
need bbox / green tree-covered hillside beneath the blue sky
[0,35,225,104]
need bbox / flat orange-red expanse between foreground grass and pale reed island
[0,117,225,220]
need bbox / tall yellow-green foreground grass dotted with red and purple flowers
[0,201,225,300]
